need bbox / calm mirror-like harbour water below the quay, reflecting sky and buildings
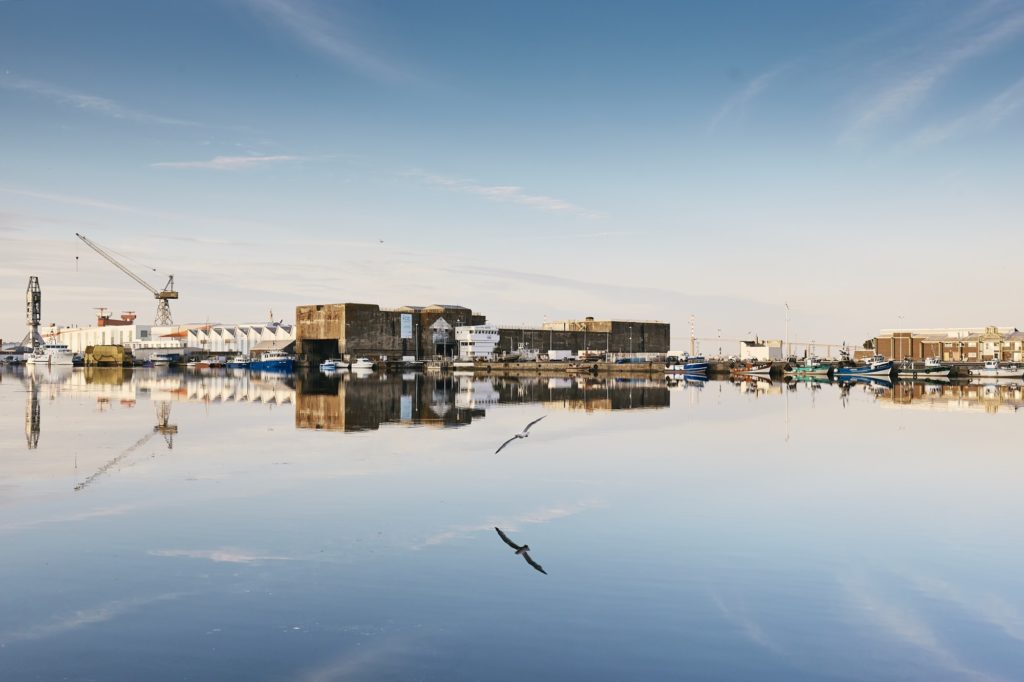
[0,370,1024,680]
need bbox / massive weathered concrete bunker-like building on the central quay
[295,303,670,363]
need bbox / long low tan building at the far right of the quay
[873,326,1024,363]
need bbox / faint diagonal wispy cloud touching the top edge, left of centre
[245,0,403,80]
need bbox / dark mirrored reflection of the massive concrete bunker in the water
[295,373,669,431]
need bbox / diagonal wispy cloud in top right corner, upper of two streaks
[840,13,1024,142]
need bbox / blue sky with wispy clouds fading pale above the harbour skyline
[0,0,1024,347]
